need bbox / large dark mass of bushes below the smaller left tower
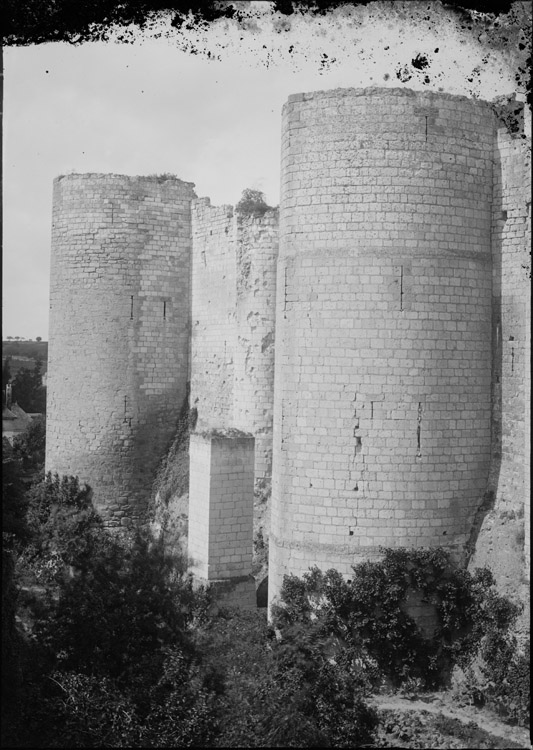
[4,475,212,747]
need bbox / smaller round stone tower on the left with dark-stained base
[46,174,195,526]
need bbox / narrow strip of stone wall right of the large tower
[471,102,531,593]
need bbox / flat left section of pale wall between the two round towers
[190,198,237,430]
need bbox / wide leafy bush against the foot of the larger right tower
[274,548,519,688]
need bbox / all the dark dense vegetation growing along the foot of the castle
[2,427,529,747]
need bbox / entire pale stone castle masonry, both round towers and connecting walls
[46,88,531,612]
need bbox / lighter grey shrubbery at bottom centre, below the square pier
[197,611,377,747]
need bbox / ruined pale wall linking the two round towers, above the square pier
[191,203,278,494]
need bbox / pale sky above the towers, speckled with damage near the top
[2,1,521,340]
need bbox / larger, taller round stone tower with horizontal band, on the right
[269,89,494,600]
